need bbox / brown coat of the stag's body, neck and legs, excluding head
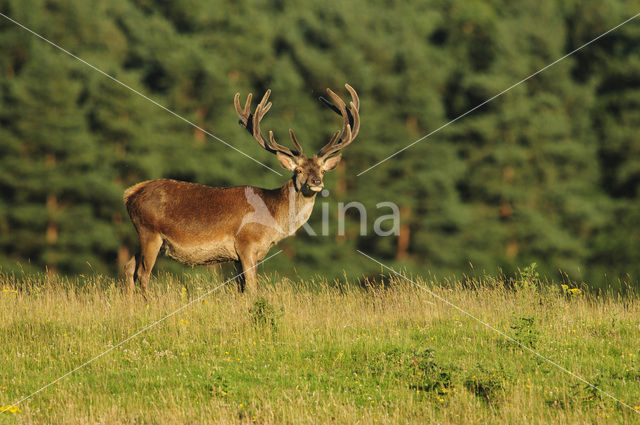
[124,177,315,294]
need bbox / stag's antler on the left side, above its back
[233,89,302,158]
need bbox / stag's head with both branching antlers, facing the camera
[233,84,360,196]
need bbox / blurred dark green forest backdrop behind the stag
[0,0,640,285]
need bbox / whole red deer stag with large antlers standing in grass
[124,84,360,298]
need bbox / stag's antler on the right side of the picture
[318,84,360,160]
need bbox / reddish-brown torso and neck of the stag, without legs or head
[124,179,315,265]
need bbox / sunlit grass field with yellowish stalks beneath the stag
[0,272,640,424]
